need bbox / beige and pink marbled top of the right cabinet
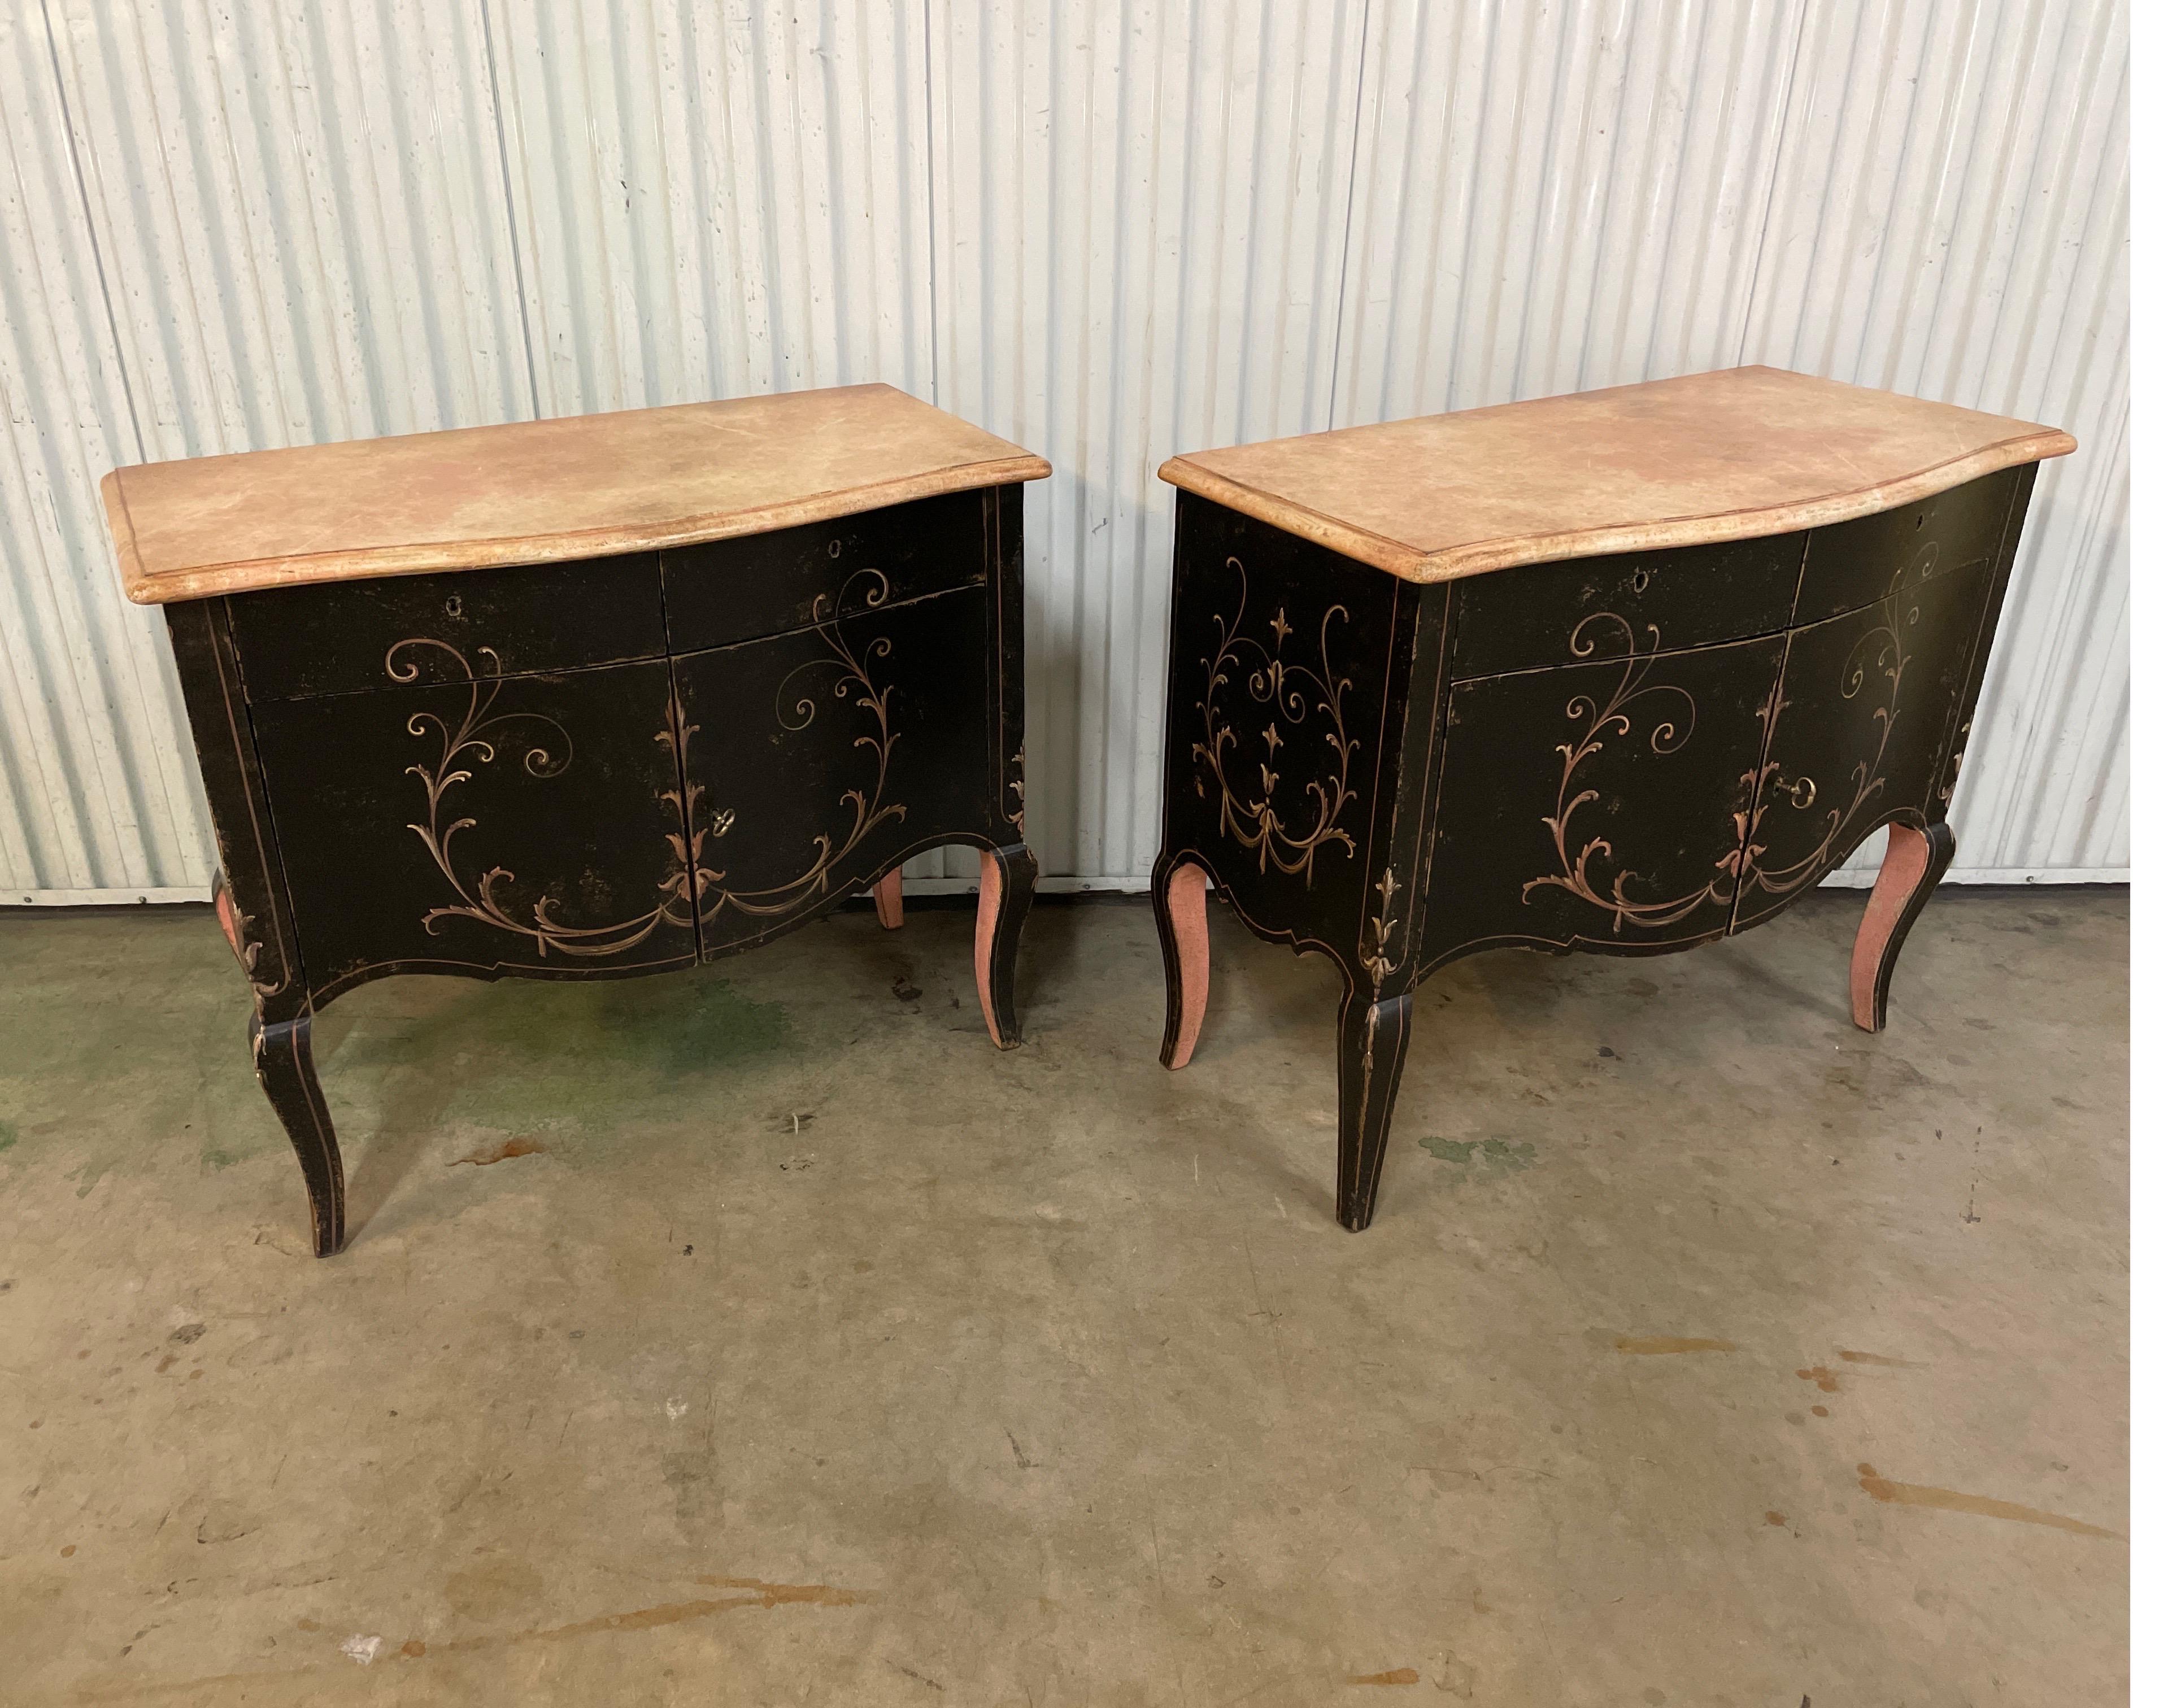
[1158,369,2074,580]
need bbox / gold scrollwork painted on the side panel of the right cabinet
[1191,559,1361,883]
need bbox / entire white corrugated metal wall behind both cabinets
[0,0,2128,901]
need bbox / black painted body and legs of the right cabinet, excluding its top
[1152,465,2035,1228]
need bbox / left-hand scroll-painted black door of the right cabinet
[1424,613,1786,960]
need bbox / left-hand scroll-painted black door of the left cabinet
[251,641,696,997]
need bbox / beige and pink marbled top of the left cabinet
[101,386,1054,604]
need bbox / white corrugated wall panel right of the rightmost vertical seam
[1743,0,2128,875]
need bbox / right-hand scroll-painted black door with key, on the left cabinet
[674,587,999,956]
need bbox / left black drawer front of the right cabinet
[1452,534,1810,681]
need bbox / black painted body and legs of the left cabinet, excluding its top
[166,484,1036,1254]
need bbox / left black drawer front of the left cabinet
[227,552,667,700]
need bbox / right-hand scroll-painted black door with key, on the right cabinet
[1734,563,1993,929]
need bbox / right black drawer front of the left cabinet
[663,491,986,652]
